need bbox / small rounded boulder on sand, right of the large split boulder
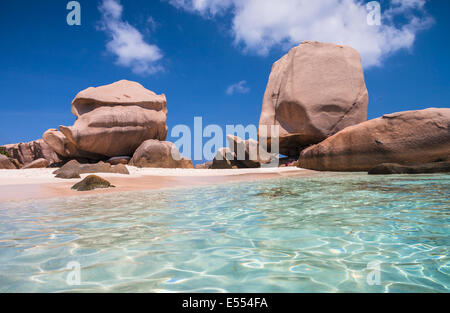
[129,139,194,168]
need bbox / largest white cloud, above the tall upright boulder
[169,0,432,67]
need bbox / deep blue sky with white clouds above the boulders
[0,0,450,155]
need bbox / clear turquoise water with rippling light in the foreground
[0,174,450,292]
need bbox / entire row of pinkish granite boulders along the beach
[0,41,450,177]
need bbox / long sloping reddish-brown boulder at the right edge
[299,108,450,171]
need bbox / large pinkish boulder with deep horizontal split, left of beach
[55,80,167,157]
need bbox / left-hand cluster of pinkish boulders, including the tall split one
[0,80,193,168]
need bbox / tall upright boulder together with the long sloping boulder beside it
[255,41,450,173]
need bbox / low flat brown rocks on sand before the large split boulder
[53,160,130,179]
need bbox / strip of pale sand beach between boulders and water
[0,166,323,202]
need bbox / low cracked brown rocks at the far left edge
[0,139,61,165]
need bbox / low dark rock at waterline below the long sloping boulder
[369,162,450,175]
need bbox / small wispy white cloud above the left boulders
[99,0,162,74]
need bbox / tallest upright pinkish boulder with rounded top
[259,41,369,157]
